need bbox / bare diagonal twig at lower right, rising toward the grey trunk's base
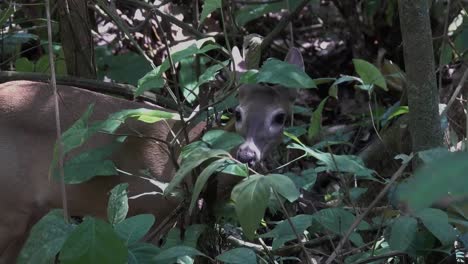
[325,155,412,264]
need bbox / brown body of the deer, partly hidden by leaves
[0,81,191,263]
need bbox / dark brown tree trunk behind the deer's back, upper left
[56,0,96,79]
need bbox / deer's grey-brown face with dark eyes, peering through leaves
[235,48,304,165]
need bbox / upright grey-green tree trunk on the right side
[398,0,442,152]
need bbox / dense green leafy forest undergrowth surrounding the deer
[0,0,468,264]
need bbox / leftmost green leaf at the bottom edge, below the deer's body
[18,210,73,264]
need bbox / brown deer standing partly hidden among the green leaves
[0,48,304,263]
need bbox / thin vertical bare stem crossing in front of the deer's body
[45,0,69,223]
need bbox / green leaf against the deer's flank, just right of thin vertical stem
[54,144,118,184]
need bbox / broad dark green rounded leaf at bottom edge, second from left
[59,217,128,264]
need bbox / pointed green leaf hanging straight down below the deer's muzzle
[231,174,270,239]
